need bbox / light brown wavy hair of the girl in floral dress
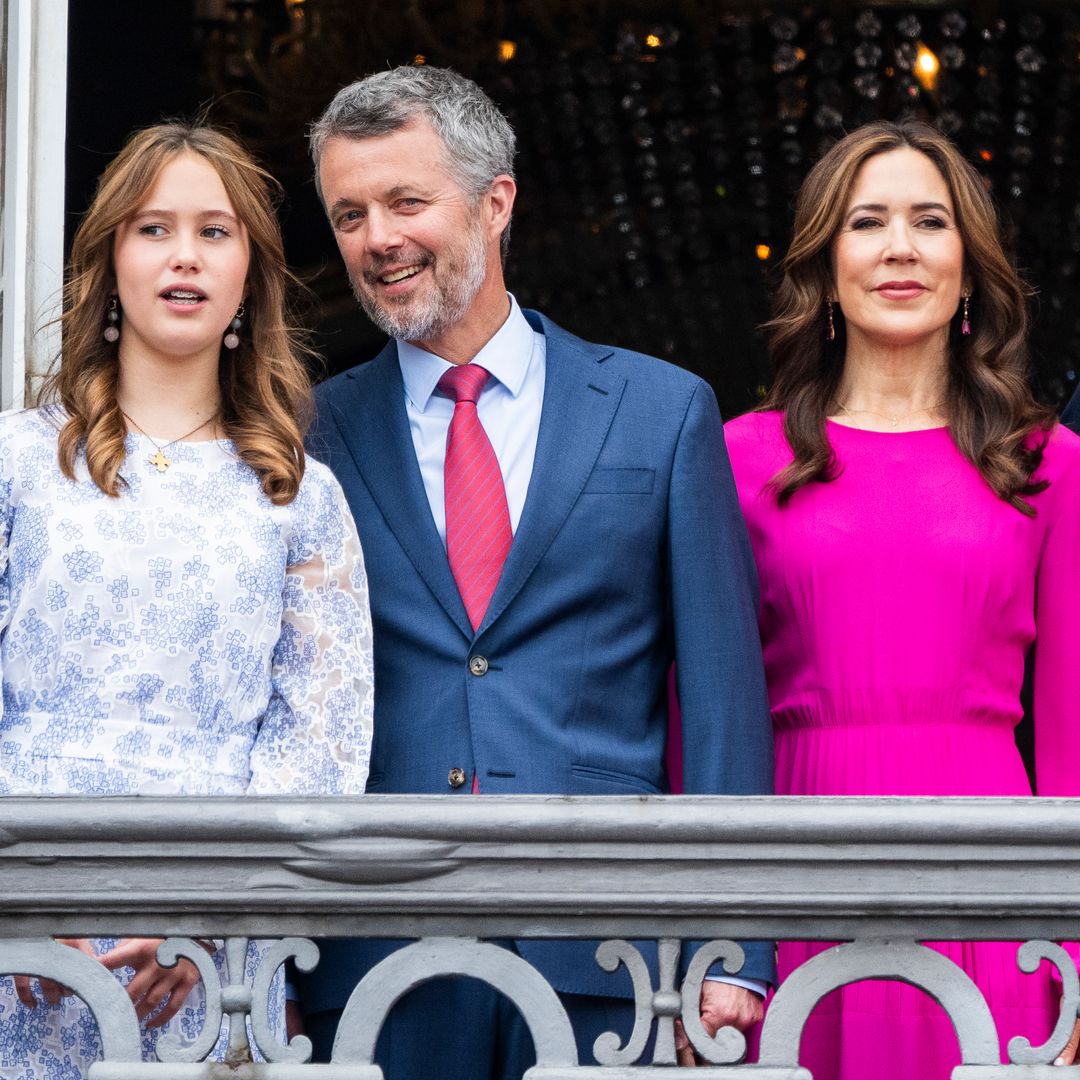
[39,121,312,505]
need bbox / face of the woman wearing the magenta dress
[833,147,963,350]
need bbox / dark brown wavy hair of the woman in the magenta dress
[761,121,1054,515]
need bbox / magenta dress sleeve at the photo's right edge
[1035,428,1080,796]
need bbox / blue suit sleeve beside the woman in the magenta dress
[669,382,777,984]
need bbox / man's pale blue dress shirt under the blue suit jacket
[397,296,767,997]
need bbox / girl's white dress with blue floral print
[0,409,373,1080]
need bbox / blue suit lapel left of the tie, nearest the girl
[329,342,474,640]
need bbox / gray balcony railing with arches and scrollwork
[0,796,1080,1080]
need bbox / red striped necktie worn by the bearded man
[438,364,513,630]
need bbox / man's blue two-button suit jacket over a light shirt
[305,311,773,1012]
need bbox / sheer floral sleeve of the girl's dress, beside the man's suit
[248,459,374,795]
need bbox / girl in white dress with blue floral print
[0,123,373,1080]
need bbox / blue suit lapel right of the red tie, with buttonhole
[479,312,626,633]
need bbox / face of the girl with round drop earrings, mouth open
[113,151,248,371]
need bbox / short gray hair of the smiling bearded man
[309,65,515,202]
